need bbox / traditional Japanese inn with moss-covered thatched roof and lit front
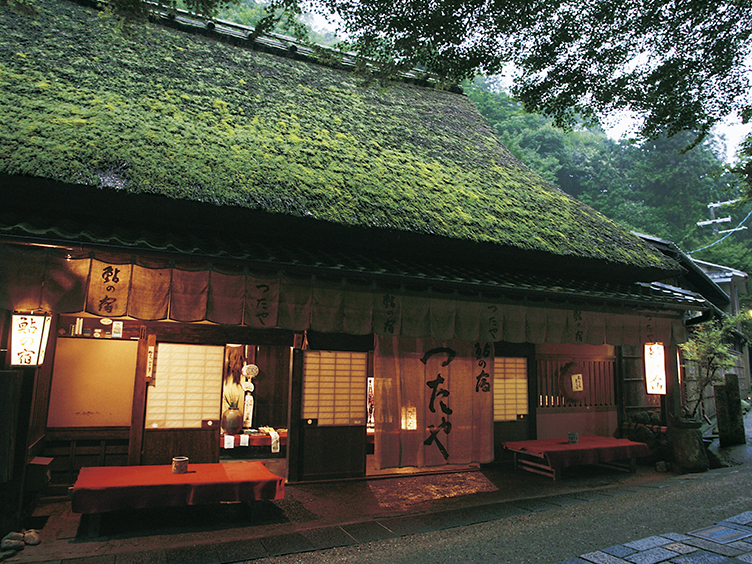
[0,0,710,532]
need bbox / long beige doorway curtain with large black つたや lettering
[374,336,493,468]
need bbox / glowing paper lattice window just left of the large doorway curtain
[303,351,368,425]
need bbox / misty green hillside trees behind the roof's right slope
[465,79,752,271]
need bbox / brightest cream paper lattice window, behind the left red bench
[146,344,225,428]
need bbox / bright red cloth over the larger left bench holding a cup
[71,462,285,513]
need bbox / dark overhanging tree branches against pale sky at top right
[298,0,752,145]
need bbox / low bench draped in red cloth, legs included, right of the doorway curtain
[504,436,651,480]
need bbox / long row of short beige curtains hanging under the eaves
[0,245,686,345]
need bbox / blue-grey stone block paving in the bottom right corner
[556,511,752,564]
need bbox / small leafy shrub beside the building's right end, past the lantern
[679,311,750,418]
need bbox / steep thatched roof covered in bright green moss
[0,0,674,270]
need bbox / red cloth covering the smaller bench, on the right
[504,437,651,470]
